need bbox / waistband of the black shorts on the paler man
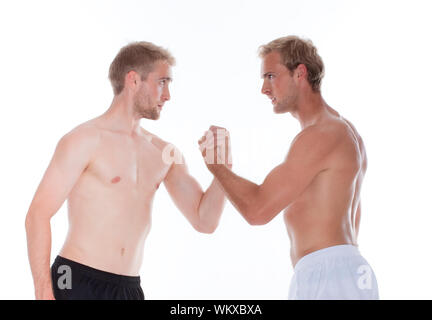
[53,256,141,286]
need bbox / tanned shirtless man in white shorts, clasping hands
[199,36,378,299]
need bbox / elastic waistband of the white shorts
[294,244,361,272]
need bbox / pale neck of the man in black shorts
[102,94,141,135]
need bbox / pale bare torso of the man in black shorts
[60,119,170,276]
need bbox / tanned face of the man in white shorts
[261,51,298,113]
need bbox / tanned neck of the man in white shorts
[291,90,328,130]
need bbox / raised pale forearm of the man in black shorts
[198,178,225,233]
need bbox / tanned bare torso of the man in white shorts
[284,108,367,266]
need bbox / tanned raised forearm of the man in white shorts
[211,166,259,223]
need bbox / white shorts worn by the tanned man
[288,245,379,300]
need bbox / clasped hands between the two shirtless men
[198,126,232,171]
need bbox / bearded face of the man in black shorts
[134,61,172,120]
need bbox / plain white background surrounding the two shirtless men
[0,0,432,299]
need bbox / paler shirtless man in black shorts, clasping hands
[26,42,230,299]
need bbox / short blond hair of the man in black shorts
[109,41,175,95]
